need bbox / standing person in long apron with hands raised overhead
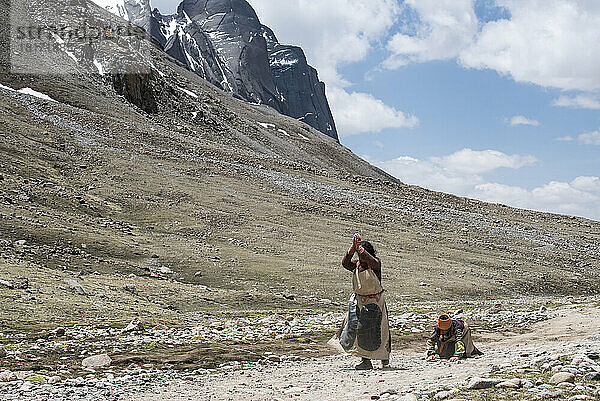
[336,234,392,370]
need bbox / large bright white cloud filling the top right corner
[459,0,600,91]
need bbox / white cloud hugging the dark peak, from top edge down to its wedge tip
[249,0,418,136]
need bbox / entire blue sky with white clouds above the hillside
[153,0,600,220]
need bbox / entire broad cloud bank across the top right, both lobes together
[383,0,600,92]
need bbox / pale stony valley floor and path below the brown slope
[0,298,600,400]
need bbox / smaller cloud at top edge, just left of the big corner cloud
[383,0,478,69]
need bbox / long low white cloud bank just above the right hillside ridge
[371,149,600,220]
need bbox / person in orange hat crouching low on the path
[427,314,482,362]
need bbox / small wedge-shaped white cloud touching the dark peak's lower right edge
[328,88,419,136]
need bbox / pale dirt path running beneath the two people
[123,307,600,401]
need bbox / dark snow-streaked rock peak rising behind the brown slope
[114,0,338,139]
